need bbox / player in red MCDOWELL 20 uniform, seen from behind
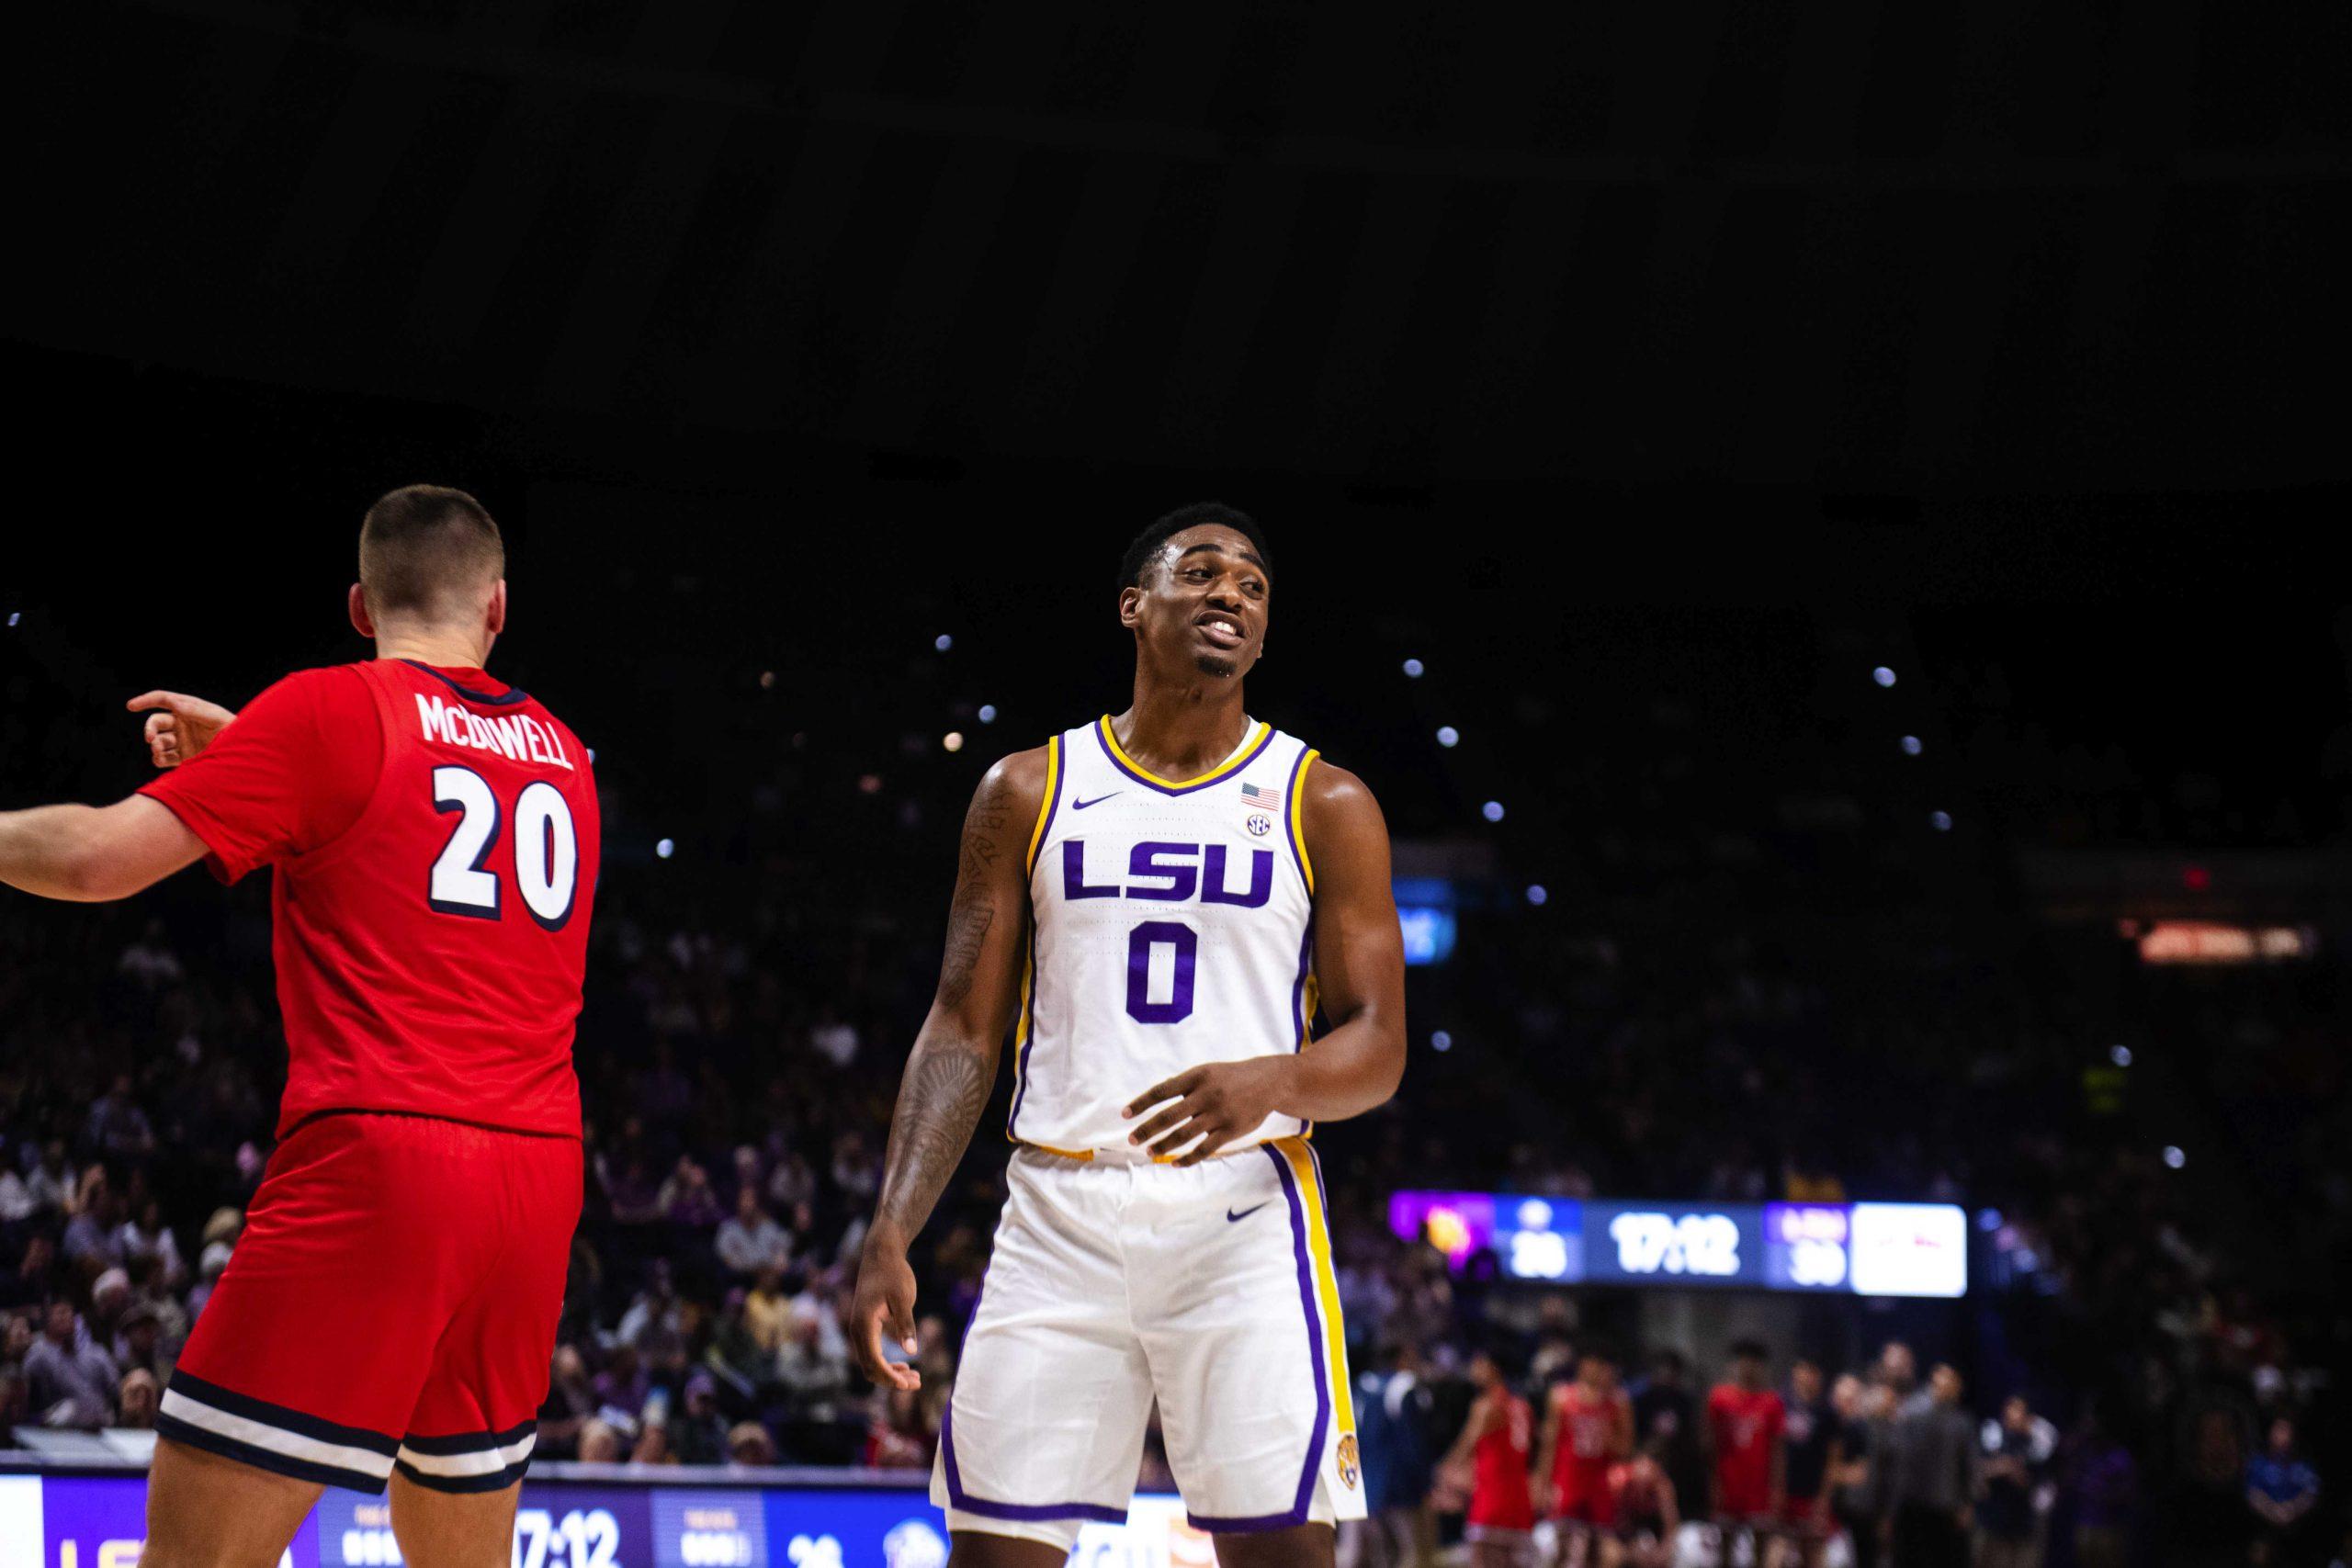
[0,487,600,1568]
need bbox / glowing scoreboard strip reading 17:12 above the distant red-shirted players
[1387,1190,1969,1298]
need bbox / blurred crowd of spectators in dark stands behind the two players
[0,846,2343,1563]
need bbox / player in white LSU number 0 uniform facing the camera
[852,505,1404,1568]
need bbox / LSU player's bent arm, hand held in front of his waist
[1125,761,1404,1166]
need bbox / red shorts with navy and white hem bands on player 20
[155,1112,581,1493]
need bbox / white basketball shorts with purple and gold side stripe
[932,1138,1364,1550]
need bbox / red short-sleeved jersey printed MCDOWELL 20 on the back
[143,659,600,1135]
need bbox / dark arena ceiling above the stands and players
[14,0,2352,493]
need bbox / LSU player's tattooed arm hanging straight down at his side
[849,750,1046,1389]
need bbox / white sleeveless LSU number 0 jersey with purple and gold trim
[1004,717,1317,1159]
